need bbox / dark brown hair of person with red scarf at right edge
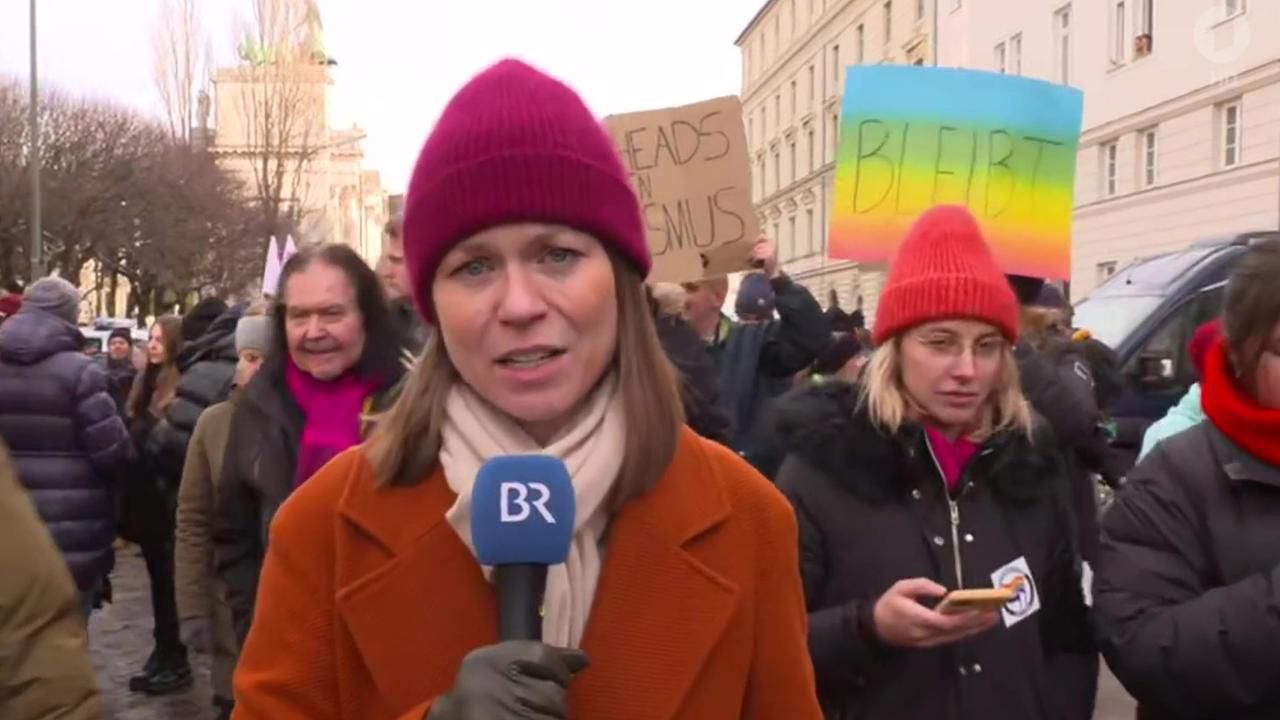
[1222,240,1280,383]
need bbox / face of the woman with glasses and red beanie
[901,320,1007,432]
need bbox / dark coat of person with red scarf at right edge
[1093,421,1280,720]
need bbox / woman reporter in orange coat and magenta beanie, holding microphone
[234,60,820,720]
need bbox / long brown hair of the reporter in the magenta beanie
[366,252,685,509]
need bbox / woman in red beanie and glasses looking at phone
[776,206,1093,720]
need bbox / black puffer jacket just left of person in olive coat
[143,306,244,492]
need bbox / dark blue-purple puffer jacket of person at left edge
[0,307,131,591]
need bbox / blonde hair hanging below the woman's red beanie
[859,337,1032,441]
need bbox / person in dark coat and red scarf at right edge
[1094,241,1280,720]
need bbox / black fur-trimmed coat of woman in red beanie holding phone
[774,383,1094,720]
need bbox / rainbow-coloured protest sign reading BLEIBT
[828,65,1084,279]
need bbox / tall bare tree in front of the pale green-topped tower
[231,0,328,237]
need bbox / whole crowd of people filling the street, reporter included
[0,60,1280,720]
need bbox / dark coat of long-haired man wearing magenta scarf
[212,361,401,644]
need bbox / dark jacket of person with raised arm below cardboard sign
[709,275,831,460]
